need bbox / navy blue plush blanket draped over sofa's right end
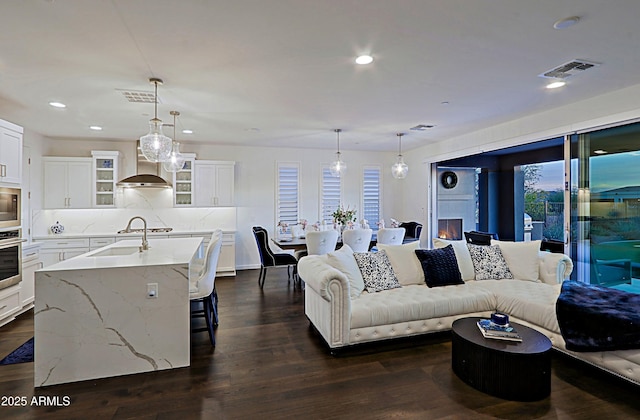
[556,281,640,351]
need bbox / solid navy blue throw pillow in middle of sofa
[416,245,464,287]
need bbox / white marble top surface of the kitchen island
[38,238,202,271]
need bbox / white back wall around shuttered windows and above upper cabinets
[33,138,402,269]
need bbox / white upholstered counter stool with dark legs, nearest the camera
[189,229,222,346]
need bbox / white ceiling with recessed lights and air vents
[0,0,640,151]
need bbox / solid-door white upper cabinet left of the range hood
[42,157,93,209]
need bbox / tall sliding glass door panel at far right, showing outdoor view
[571,124,640,292]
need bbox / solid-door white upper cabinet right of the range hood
[194,160,235,207]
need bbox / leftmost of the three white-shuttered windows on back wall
[276,163,300,231]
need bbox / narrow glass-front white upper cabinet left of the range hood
[91,150,120,208]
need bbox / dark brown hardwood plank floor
[0,269,640,420]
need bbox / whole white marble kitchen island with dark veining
[34,238,202,387]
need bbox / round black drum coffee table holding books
[451,318,551,401]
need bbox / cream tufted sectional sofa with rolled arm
[298,239,640,384]
